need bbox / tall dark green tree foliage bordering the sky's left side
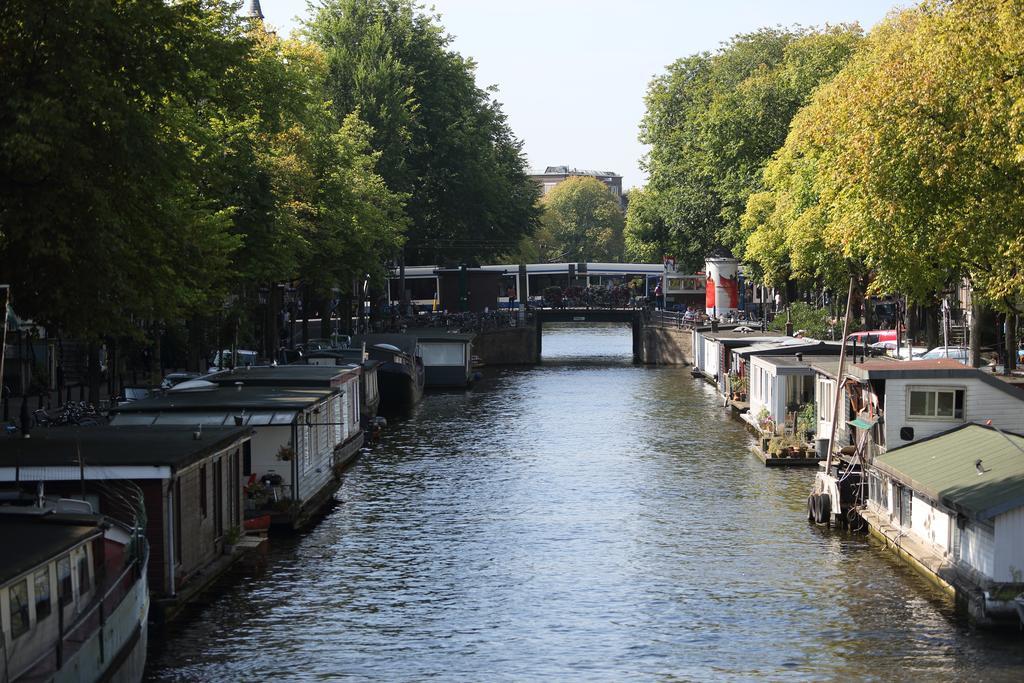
[306,0,539,262]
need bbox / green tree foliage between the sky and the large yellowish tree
[627,25,861,267]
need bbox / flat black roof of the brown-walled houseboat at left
[0,426,252,469]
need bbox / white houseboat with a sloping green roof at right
[861,423,1024,629]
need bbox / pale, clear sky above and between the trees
[262,0,908,188]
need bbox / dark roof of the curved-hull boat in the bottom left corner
[0,513,103,584]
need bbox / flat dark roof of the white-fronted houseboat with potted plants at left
[113,385,337,413]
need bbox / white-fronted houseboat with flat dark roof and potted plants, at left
[112,378,362,531]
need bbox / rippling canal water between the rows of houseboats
[148,326,1024,681]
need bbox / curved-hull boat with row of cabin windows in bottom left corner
[0,493,150,683]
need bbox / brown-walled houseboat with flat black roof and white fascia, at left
[0,425,252,623]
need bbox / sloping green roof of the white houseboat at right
[874,423,1024,520]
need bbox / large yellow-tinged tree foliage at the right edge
[748,0,1024,305]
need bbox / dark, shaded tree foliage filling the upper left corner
[0,0,238,338]
